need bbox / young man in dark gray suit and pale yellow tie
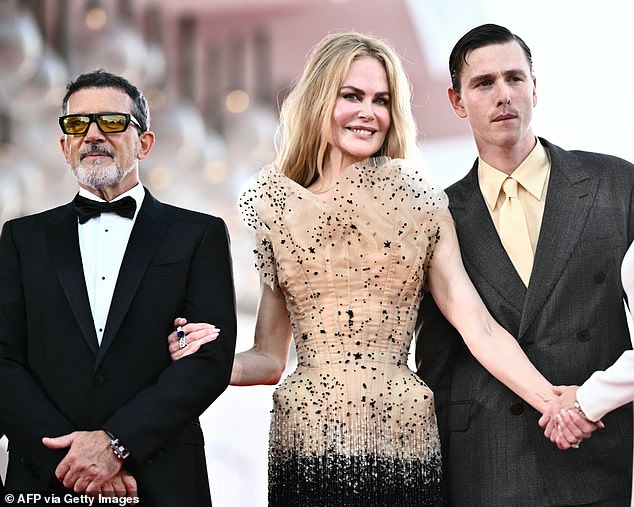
[416,25,634,507]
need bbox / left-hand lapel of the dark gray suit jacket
[449,161,526,313]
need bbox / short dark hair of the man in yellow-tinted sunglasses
[62,69,150,132]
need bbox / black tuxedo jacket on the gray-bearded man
[0,190,236,506]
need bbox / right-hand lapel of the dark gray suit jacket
[519,144,598,336]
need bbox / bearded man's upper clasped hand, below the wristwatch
[42,430,122,494]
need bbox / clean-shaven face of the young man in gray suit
[449,41,537,158]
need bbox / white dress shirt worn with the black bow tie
[77,183,145,345]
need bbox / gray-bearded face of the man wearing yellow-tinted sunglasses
[60,88,154,200]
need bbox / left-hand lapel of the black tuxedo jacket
[47,205,99,355]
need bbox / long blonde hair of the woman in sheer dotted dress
[275,32,417,187]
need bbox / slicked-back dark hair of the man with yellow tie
[449,23,533,92]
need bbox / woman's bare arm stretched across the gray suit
[427,217,559,415]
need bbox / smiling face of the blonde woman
[327,56,391,167]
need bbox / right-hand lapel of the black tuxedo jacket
[96,190,167,366]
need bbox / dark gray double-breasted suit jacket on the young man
[416,139,634,507]
